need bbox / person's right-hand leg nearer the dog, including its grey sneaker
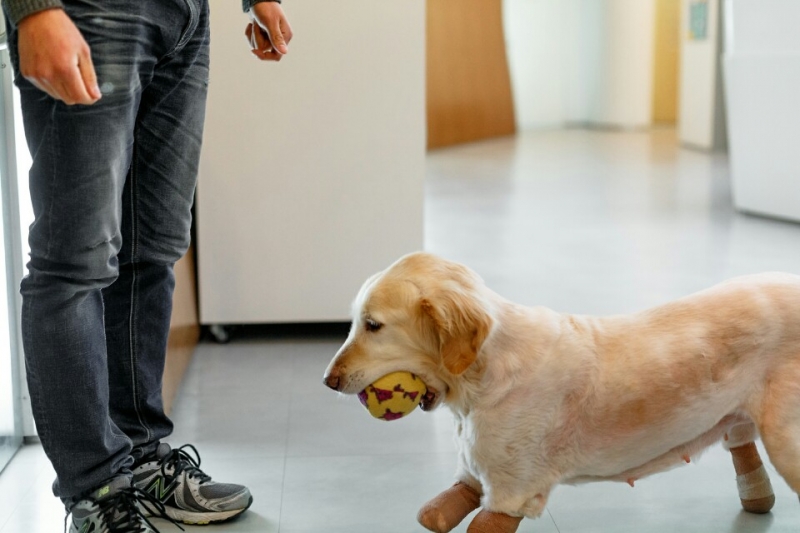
[115,0,253,524]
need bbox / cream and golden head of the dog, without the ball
[324,253,493,410]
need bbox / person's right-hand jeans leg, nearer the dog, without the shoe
[103,0,209,460]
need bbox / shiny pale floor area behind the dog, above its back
[425,130,800,314]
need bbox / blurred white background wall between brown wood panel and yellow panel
[504,0,655,130]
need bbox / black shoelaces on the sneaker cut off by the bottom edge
[64,487,184,533]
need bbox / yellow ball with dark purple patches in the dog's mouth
[358,372,428,422]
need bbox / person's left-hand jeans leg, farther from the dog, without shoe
[2,1,166,500]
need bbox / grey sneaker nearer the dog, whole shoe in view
[133,443,253,525]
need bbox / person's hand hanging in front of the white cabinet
[244,2,292,61]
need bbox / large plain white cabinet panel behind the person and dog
[196,0,425,324]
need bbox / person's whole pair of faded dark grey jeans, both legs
[4,0,209,499]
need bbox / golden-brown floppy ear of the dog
[420,287,492,375]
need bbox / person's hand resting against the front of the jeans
[18,9,102,105]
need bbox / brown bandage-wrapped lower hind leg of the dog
[723,422,775,514]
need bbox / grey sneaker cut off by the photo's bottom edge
[65,477,166,533]
